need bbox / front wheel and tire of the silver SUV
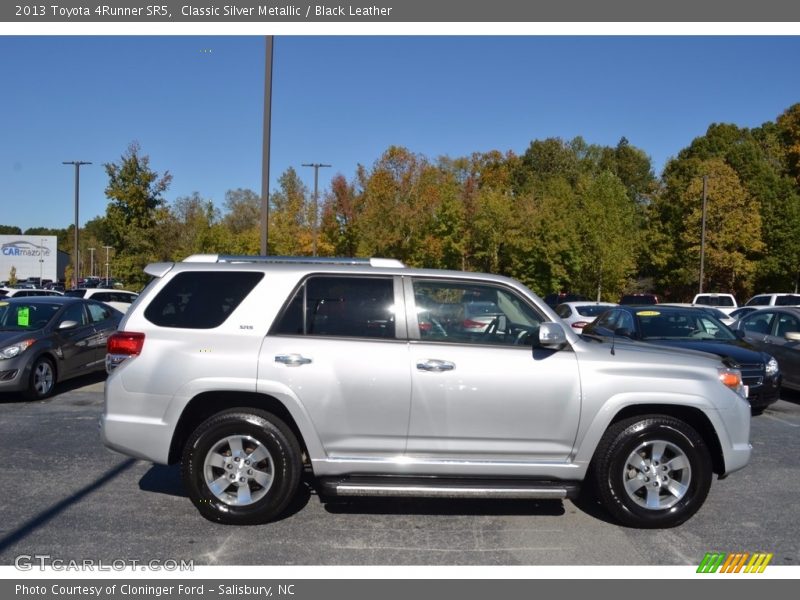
[591,415,713,528]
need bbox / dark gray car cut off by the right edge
[733,306,800,390]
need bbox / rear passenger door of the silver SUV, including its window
[258,275,410,459]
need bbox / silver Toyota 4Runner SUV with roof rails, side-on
[101,255,751,527]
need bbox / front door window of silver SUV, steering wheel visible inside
[413,280,543,346]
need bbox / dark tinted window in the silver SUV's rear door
[271,275,396,339]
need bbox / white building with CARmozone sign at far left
[0,235,70,281]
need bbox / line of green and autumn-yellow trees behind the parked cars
[0,103,800,301]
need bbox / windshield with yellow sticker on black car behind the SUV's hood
[636,310,736,341]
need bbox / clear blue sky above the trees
[0,36,800,230]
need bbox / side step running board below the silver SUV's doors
[320,476,580,500]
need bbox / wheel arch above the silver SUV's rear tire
[167,391,310,464]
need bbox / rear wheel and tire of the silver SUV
[181,408,302,525]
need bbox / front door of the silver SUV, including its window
[406,278,581,464]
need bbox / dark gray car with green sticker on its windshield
[0,296,122,400]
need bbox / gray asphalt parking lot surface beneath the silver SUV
[0,376,800,565]
